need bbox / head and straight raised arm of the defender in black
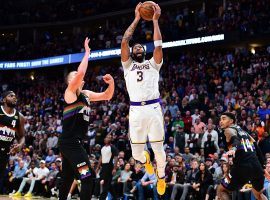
[64,38,90,103]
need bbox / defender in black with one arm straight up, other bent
[58,38,114,200]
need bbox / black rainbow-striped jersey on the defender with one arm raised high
[59,93,90,143]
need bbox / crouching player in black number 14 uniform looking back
[219,112,267,200]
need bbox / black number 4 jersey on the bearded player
[0,106,20,150]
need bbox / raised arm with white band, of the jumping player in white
[153,4,163,64]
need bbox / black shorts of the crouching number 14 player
[221,160,264,191]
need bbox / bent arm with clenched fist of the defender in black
[82,74,114,101]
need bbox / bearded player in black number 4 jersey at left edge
[0,91,25,177]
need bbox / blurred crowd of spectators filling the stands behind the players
[0,0,270,200]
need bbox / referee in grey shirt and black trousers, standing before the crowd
[97,135,118,200]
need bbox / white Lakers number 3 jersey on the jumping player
[122,58,163,102]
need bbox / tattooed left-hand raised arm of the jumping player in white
[121,2,142,62]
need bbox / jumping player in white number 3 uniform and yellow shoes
[121,3,166,195]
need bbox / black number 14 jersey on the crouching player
[228,126,258,165]
